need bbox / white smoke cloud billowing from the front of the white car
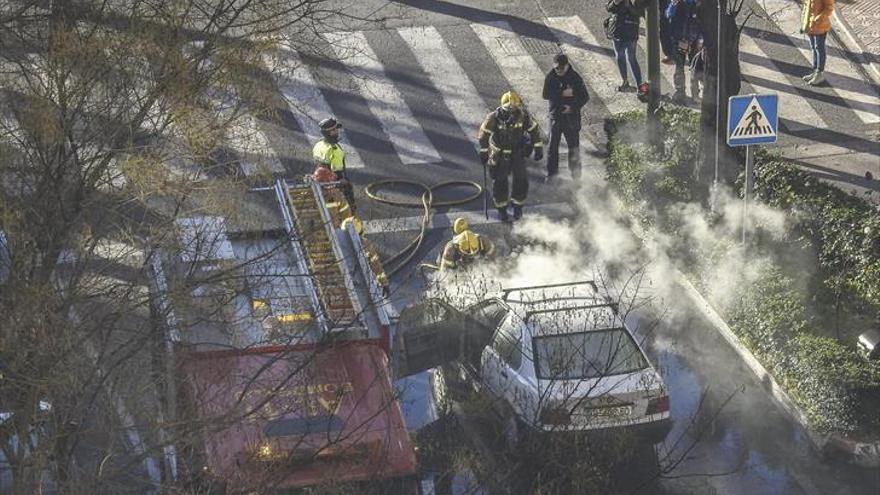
[432,174,790,326]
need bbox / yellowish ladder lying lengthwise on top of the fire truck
[279,180,361,330]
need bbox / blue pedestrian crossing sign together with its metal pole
[727,94,779,245]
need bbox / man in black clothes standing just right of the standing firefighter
[543,53,590,180]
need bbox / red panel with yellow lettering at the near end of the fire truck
[181,341,416,489]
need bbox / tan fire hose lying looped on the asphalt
[364,179,484,277]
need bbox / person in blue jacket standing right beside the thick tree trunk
[665,0,703,103]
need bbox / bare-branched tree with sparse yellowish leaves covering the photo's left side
[0,0,386,493]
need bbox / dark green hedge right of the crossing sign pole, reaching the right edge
[755,155,880,308]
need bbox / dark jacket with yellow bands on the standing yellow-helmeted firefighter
[477,107,544,166]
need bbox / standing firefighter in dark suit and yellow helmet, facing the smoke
[478,91,544,222]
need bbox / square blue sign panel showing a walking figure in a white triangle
[727,94,779,146]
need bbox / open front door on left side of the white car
[393,299,490,378]
